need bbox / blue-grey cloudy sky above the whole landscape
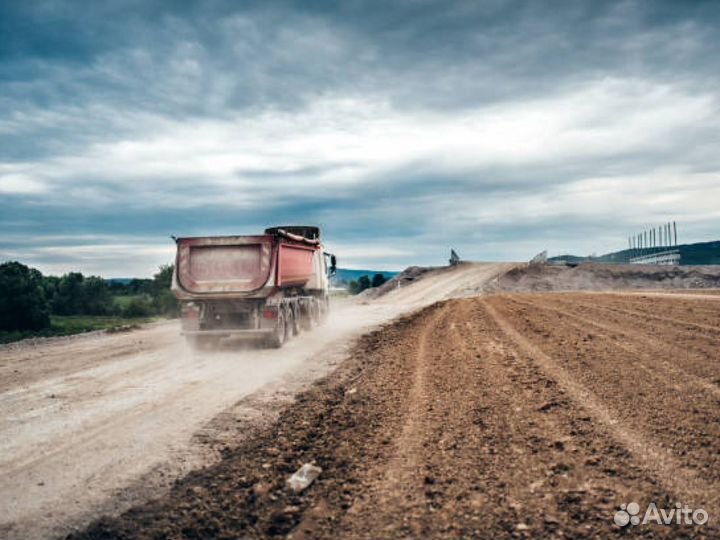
[0,0,720,277]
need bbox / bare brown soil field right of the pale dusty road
[71,293,720,539]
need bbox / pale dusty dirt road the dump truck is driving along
[0,264,508,539]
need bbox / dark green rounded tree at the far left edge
[0,261,50,331]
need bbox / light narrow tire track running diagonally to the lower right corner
[482,298,720,515]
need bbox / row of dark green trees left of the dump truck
[0,261,178,331]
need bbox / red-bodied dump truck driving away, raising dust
[172,226,336,349]
